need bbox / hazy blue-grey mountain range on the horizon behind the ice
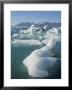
[12,22,61,30]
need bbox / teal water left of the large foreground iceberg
[11,46,40,79]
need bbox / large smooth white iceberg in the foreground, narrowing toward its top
[23,29,59,77]
